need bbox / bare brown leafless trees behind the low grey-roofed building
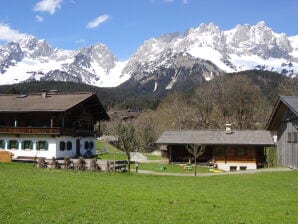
[103,73,298,154]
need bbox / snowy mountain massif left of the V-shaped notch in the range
[0,36,129,86]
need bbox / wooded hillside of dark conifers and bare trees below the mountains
[0,71,298,150]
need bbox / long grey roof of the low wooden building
[156,130,274,146]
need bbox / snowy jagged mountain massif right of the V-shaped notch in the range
[123,22,298,90]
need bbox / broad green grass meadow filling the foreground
[0,163,298,224]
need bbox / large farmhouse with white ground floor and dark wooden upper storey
[0,90,109,159]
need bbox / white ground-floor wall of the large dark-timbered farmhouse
[0,135,96,159]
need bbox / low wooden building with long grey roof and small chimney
[156,127,274,171]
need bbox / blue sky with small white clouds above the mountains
[0,0,298,60]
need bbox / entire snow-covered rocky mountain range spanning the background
[0,22,298,88]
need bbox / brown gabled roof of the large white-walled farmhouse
[0,92,109,119]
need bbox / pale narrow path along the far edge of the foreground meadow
[139,167,292,177]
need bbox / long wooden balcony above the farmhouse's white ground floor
[0,127,94,137]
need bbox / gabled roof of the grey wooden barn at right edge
[266,96,298,130]
